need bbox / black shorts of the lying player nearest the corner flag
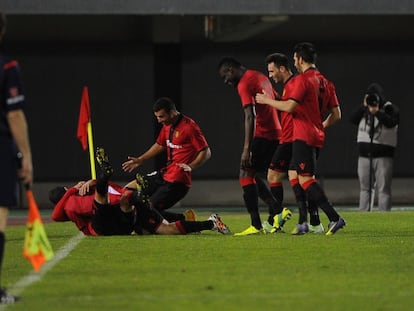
[92,201,135,235]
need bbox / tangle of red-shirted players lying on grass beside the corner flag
[49,148,230,236]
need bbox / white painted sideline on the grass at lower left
[0,232,85,310]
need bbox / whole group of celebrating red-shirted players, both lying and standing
[49,42,346,236]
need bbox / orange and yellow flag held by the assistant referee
[23,188,54,271]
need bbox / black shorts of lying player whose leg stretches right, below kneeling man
[134,204,164,234]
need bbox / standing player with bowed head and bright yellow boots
[218,57,292,236]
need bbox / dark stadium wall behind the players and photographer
[0,0,414,205]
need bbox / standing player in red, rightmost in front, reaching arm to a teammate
[256,42,346,235]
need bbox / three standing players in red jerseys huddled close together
[218,42,345,236]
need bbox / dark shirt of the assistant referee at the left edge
[0,54,25,136]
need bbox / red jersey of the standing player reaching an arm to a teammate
[285,68,325,148]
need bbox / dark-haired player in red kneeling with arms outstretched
[122,97,211,222]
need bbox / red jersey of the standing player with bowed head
[237,70,281,140]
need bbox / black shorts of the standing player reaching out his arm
[292,140,319,176]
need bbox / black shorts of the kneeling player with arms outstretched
[143,172,189,211]
